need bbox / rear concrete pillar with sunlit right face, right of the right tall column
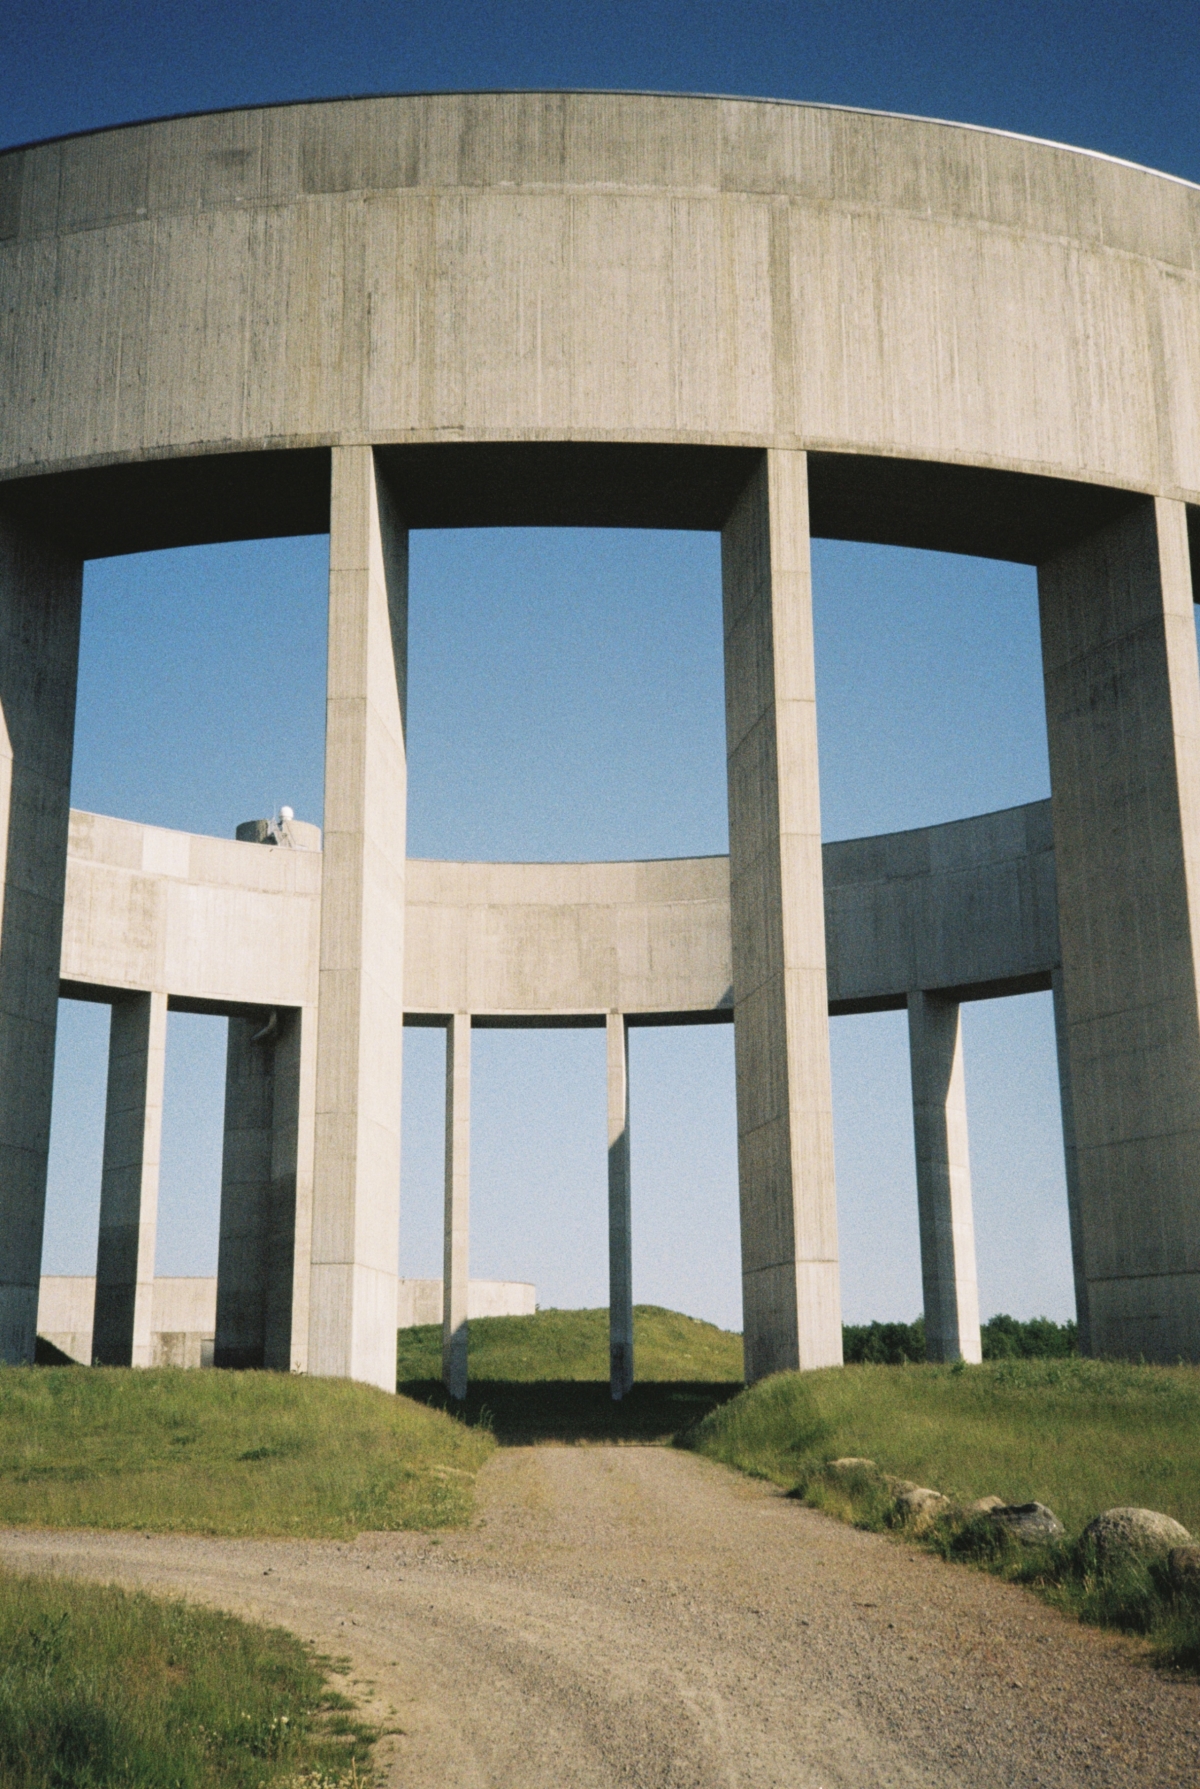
[908,993,984,1361]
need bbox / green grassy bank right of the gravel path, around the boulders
[687,1358,1200,1669]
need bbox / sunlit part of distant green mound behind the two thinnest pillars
[397,1304,742,1385]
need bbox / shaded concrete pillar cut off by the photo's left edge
[0,513,82,1365]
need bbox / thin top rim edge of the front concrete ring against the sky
[0,88,1200,191]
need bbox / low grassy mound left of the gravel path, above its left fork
[0,1367,492,1537]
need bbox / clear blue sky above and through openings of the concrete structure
[18,0,1200,1327]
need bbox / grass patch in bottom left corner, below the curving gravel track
[0,1573,376,1789]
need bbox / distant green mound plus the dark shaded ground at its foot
[397,1304,742,1444]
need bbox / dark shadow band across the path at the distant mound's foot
[397,1379,742,1447]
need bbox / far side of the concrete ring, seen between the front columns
[63,801,1059,1025]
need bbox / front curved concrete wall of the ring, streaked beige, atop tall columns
[0,93,1200,501]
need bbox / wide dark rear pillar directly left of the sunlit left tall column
[213,1007,311,1372]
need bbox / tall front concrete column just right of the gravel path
[721,451,842,1381]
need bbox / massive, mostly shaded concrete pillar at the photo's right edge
[1039,499,1200,1361]
